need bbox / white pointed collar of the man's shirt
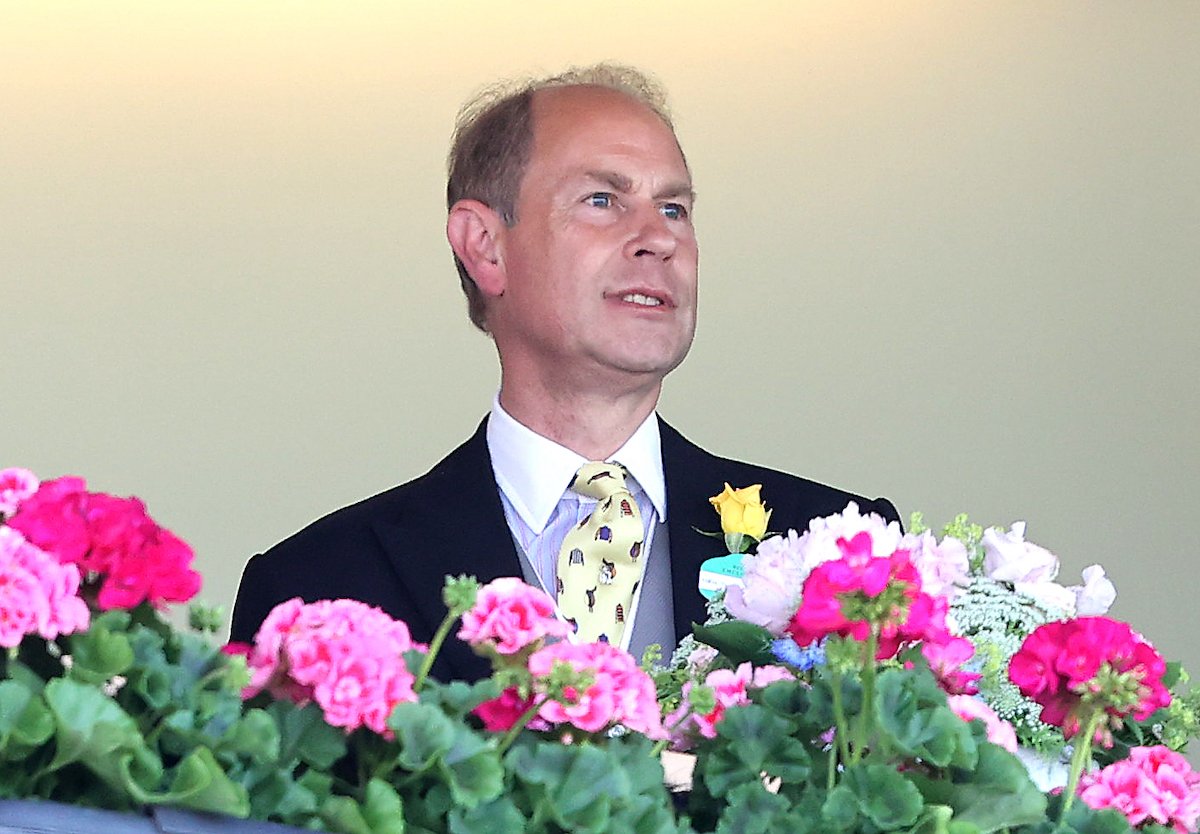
[487,394,667,533]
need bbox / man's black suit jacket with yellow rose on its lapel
[230,419,896,680]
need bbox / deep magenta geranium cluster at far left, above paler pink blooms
[7,478,200,611]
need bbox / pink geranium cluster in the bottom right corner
[1079,746,1200,834]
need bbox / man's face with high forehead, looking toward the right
[488,88,697,388]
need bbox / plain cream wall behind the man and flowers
[0,0,1200,715]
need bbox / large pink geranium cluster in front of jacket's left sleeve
[242,598,427,738]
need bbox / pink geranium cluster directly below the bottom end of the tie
[529,641,666,739]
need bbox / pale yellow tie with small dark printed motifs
[557,462,646,646]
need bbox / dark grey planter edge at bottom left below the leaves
[0,799,311,834]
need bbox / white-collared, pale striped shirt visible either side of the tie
[487,395,667,648]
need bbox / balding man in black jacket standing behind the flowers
[232,66,896,678]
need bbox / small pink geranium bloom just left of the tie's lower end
[458,576,571,655]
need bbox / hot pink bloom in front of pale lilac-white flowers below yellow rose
[787,530,949,660]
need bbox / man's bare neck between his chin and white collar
[500,382,661,461]
